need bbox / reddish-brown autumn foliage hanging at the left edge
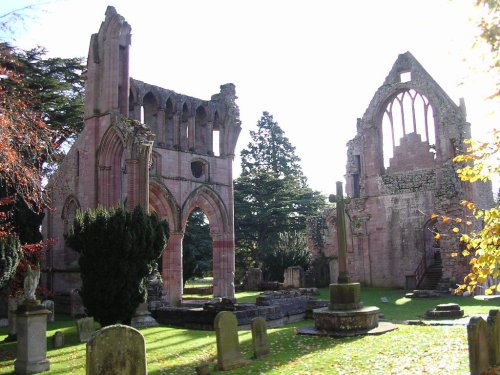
[0,44,53,296]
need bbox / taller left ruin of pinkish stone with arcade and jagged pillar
[42,7,241,310]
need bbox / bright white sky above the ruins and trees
[0,0,500,193]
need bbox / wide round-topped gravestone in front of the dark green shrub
[86,324,147,375]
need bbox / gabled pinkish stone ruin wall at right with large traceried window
[309,52,493,287]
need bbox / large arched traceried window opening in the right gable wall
[382,89,436,170]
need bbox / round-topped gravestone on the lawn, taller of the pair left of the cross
[214,311,245,371]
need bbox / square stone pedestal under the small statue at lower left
[14,303,50,374]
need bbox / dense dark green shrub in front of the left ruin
[68,207,168,326]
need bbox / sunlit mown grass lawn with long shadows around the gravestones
[0,288,500,374]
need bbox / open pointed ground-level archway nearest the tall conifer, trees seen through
[182,208,213,294]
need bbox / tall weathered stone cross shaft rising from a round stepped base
[329,181,350,284]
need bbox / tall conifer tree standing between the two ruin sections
[234,112,326,277]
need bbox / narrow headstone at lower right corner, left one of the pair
[467,316,490,375]
